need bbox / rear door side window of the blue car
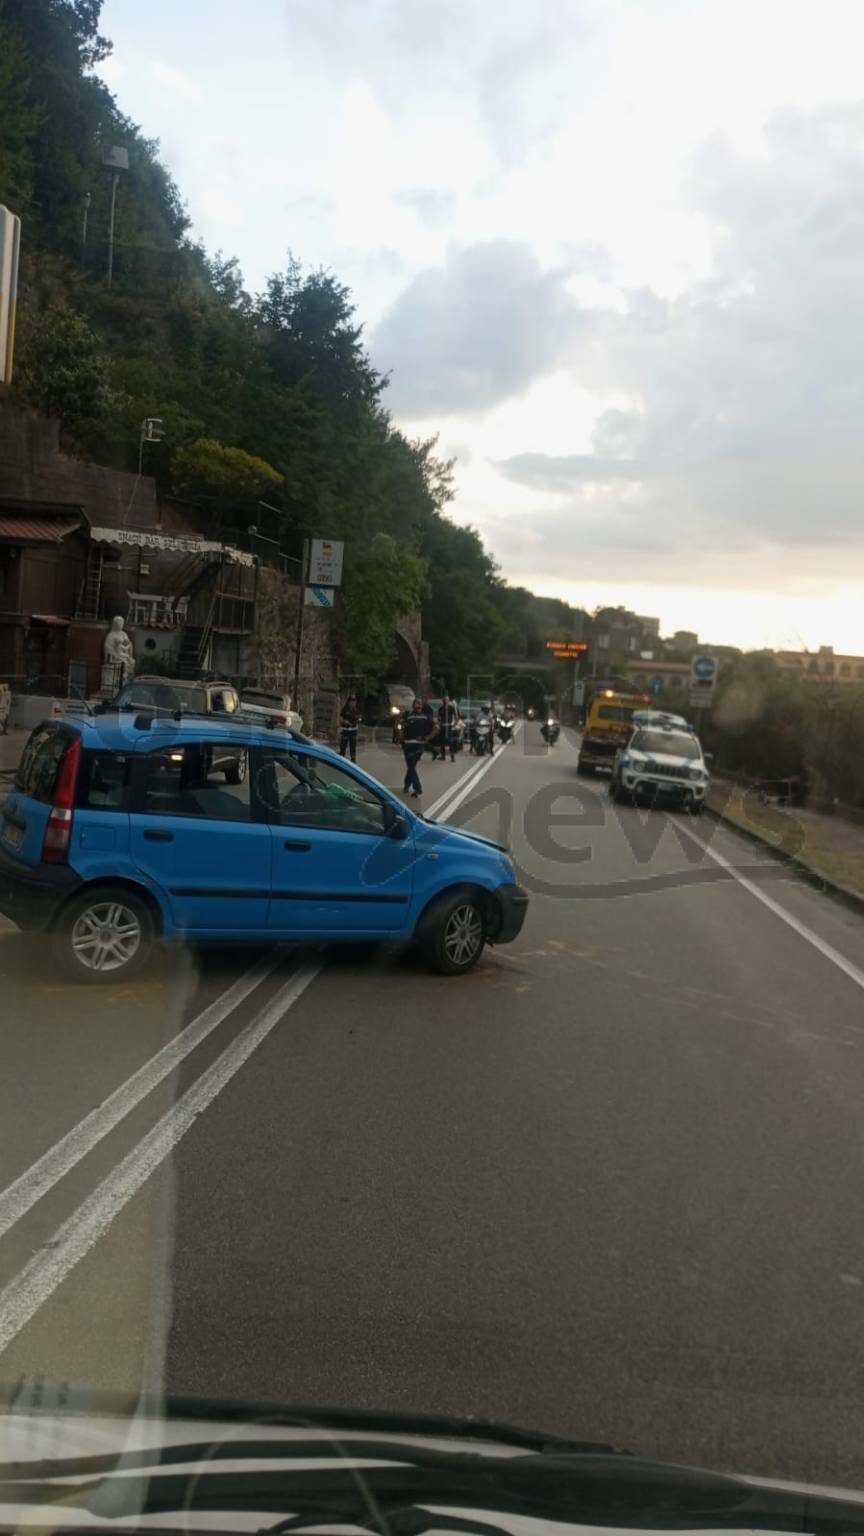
[141,742,251,822]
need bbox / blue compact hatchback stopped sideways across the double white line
[0,713,527,982]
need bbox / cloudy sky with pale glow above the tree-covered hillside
[103,0,864,651]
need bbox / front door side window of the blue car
[258,750,384,836]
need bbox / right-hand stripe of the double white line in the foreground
[0,965,321,1352]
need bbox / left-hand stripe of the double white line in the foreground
[0,954,281,1238]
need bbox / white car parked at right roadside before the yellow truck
[609,725,710,816]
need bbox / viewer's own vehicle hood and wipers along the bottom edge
[0,1381,864,1536]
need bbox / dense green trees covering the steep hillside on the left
[0,0,578,688]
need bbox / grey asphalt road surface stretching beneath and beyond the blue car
[0,725,864,1487]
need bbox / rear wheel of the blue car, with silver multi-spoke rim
[54,886,154,983]
